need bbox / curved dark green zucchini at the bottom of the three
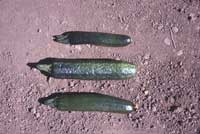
[39,92,136,113]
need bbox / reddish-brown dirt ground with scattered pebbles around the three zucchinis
[0,0,200,134]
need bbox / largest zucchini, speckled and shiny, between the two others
[28,58,136,80]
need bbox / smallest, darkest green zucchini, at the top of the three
[53,31,132,47]
